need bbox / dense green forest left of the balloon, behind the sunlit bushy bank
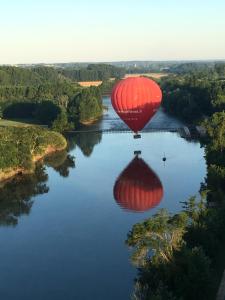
[0,65,112,132]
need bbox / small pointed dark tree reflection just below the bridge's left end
[68,132,102,157]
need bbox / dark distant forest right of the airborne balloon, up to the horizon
[160,63,225,122]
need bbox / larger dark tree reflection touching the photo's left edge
[0,166,49,226]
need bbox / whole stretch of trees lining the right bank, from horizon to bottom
[126,65,225,300]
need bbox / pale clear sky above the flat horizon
[0,0,225,64]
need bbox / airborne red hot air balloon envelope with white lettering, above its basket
[111,77,162,133]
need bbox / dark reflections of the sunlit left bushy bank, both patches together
[0,151,75,226]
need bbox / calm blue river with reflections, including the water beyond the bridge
[0,97,206,300]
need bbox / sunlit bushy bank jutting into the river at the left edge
[0,126,67,179]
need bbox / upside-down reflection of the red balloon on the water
[113,156,163,212]
